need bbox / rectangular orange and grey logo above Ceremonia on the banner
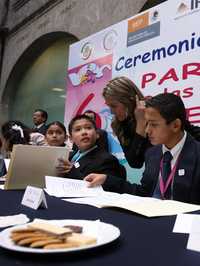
[127,10,160,47]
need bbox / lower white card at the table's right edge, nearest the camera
[187,215,200,251]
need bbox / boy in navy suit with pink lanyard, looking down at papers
[85,93,200,204]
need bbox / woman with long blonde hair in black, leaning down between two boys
[103,76,151,168]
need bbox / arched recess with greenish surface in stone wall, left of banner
[2,32,77,126]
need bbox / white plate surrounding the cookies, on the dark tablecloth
[0,220,120,253]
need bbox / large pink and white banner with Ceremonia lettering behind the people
[65,0,200,181]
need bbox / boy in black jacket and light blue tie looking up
[57,115,126,188]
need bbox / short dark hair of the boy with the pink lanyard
[146,93,186,130]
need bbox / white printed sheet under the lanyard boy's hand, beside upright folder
[45,176,103,198]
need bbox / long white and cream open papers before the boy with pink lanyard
[63,193,200,217]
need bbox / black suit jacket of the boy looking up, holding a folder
[65,147,126,189]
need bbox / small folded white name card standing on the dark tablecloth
[21,186,47,210]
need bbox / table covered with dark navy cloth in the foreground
[0,190,200,266]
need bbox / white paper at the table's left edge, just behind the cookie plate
[0,214,29,227]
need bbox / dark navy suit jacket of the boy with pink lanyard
[105,134,200,204]
